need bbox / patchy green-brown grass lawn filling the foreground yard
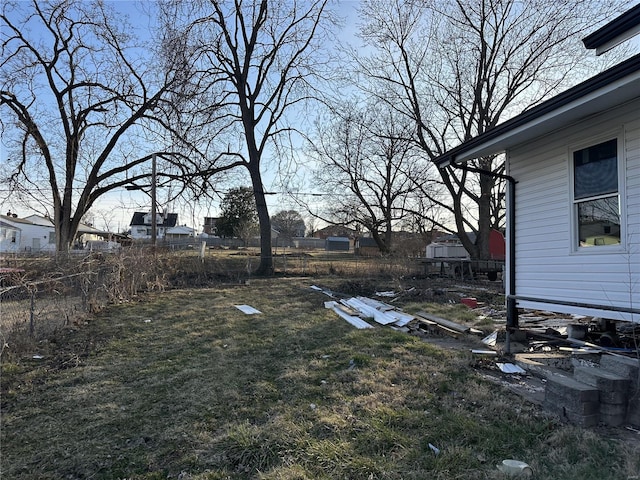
[0,278,640,480]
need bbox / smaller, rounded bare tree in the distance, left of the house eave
[312,101,440,253]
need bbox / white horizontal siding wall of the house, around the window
[508,99,640,323]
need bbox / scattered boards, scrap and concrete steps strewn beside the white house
[312,286,640,430]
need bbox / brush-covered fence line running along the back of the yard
[0,246,440,356]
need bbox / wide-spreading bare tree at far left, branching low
[0,0,216,252]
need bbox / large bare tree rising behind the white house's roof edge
[352,0,620,258]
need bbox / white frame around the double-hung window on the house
[568,129,627,251]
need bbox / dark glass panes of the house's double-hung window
[573,139,620,247]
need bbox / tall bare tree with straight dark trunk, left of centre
[162,0,336,274]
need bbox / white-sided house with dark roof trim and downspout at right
[436,11,640,326]
